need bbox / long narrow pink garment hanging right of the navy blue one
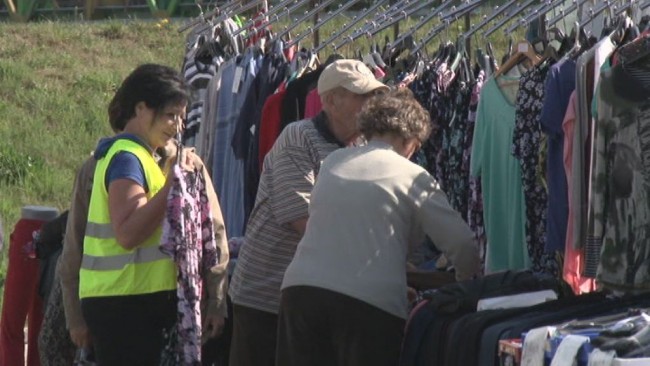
[562,90,596,295]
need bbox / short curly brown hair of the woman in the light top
[358,88,431,142]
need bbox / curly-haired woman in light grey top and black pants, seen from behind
[276,89,480,366]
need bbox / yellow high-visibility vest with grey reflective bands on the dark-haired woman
[79,139,177,299]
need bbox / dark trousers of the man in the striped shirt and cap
[230,304,278,366]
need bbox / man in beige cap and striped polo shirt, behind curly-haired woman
[229,60,388,366]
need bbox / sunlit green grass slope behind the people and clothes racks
[0,9,520,312]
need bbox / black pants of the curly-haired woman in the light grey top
[276,286,405,366]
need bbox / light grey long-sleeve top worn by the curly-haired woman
[280,141,480,319]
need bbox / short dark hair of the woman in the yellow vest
[108,64,189,132]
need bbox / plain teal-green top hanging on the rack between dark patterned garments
[470,78,530,272]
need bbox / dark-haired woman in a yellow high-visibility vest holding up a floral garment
[79,64,191,366]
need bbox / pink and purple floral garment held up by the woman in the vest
[160,165,220,365]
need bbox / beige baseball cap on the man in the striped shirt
[318,60,389,94]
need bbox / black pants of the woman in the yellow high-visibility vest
[81,291,177,366]
